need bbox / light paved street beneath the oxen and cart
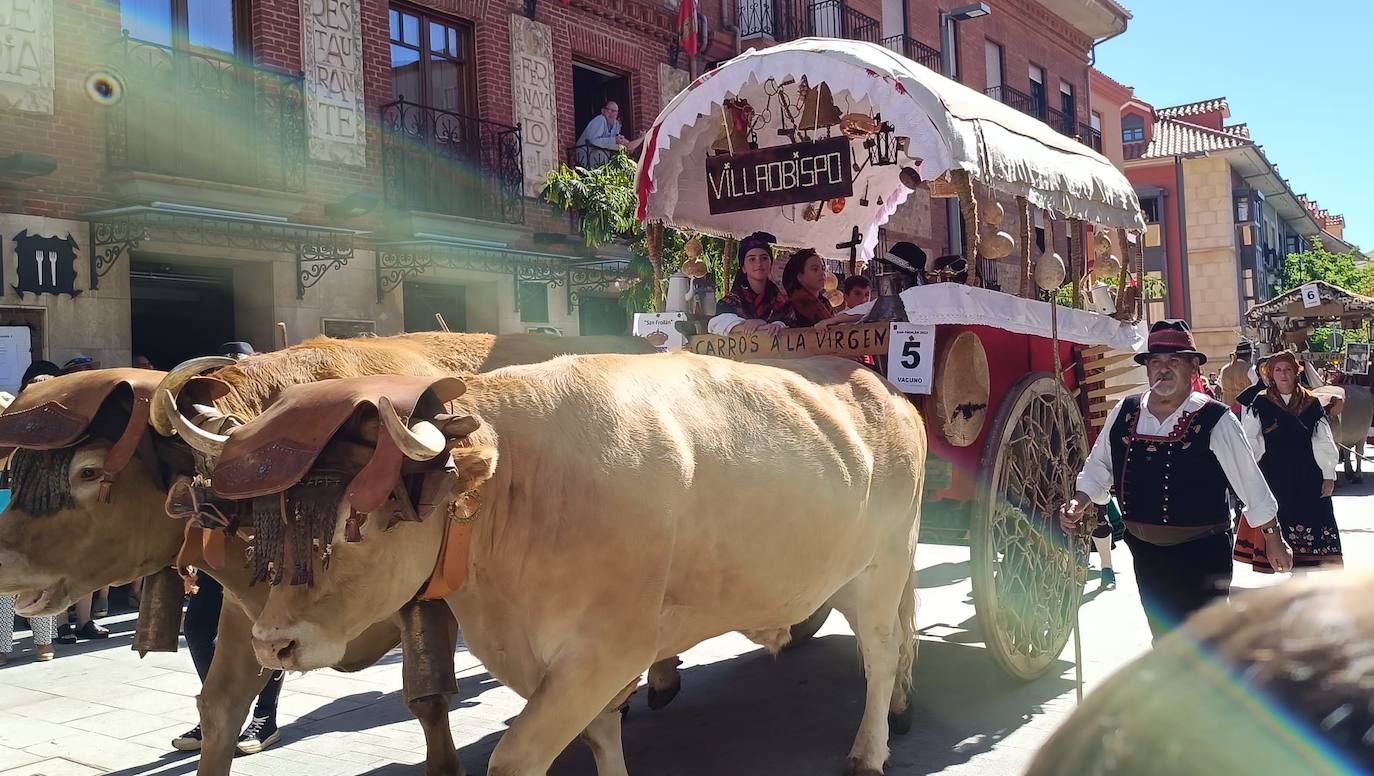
[0,483,1374,776]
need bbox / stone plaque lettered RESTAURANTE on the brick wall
[301,0,367,166]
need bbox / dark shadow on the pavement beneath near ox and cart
[412,636,1073,776]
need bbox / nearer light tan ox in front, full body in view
[188,354,926,776]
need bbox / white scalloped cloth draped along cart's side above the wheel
[852,283,1145,353]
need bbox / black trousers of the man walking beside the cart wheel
[1125,532,1232,641]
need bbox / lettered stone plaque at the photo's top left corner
[0,0,54,114]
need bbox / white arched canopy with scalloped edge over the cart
[636,38,1145,258]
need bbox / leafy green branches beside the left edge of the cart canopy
[544,152,728,312]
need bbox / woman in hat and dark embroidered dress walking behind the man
[1235,352,1342,574]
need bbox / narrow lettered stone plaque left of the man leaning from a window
[511,14,559,196]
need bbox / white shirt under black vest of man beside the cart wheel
[1077,391,1279,527]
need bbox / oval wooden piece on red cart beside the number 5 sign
[927,331,992,448]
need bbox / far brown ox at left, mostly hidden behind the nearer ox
[0,328,653,776]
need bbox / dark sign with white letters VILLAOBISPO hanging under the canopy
[706,137,855,216]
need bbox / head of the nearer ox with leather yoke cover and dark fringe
[199,376,496,670]
